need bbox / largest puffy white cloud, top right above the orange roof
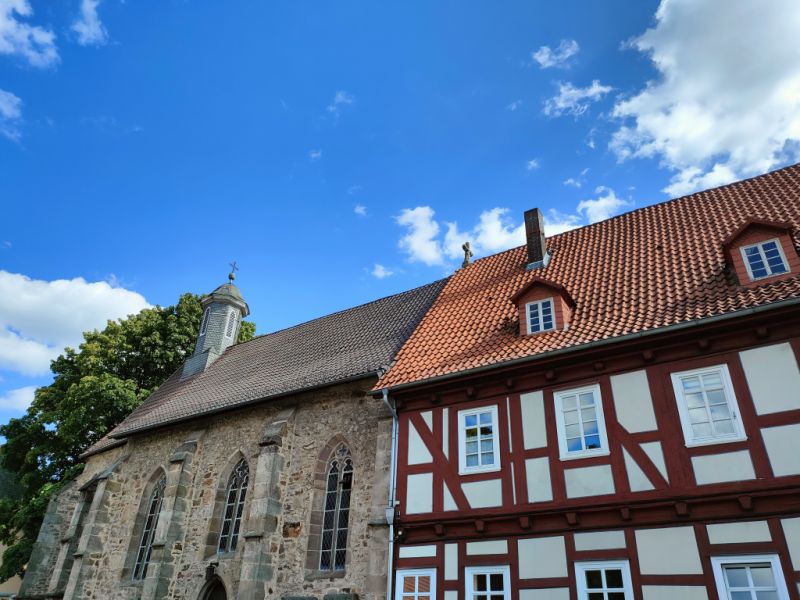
[610,0,800,195]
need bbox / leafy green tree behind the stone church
[0,294,255,581]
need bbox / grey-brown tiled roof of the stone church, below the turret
[86,279,446,455]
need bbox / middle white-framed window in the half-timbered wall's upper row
[554,385,608,458]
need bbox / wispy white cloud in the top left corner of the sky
[0,0,59,68]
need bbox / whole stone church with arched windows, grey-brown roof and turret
[19,279,445,600]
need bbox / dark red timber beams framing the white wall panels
[389,307,800,600]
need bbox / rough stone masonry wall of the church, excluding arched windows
[21,378,391,600]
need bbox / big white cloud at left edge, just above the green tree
[0,271,149,375]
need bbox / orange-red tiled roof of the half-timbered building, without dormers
[376,165,800,389]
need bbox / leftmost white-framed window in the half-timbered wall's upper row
[458,406,500,473]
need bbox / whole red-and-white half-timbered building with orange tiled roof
[375,166,800,600]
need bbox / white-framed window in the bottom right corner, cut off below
[711,555,789,600]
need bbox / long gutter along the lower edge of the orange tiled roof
[375,297,800,394]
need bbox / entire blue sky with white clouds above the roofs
[0,0,800,422]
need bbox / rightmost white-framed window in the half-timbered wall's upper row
[672,365,744,445]
